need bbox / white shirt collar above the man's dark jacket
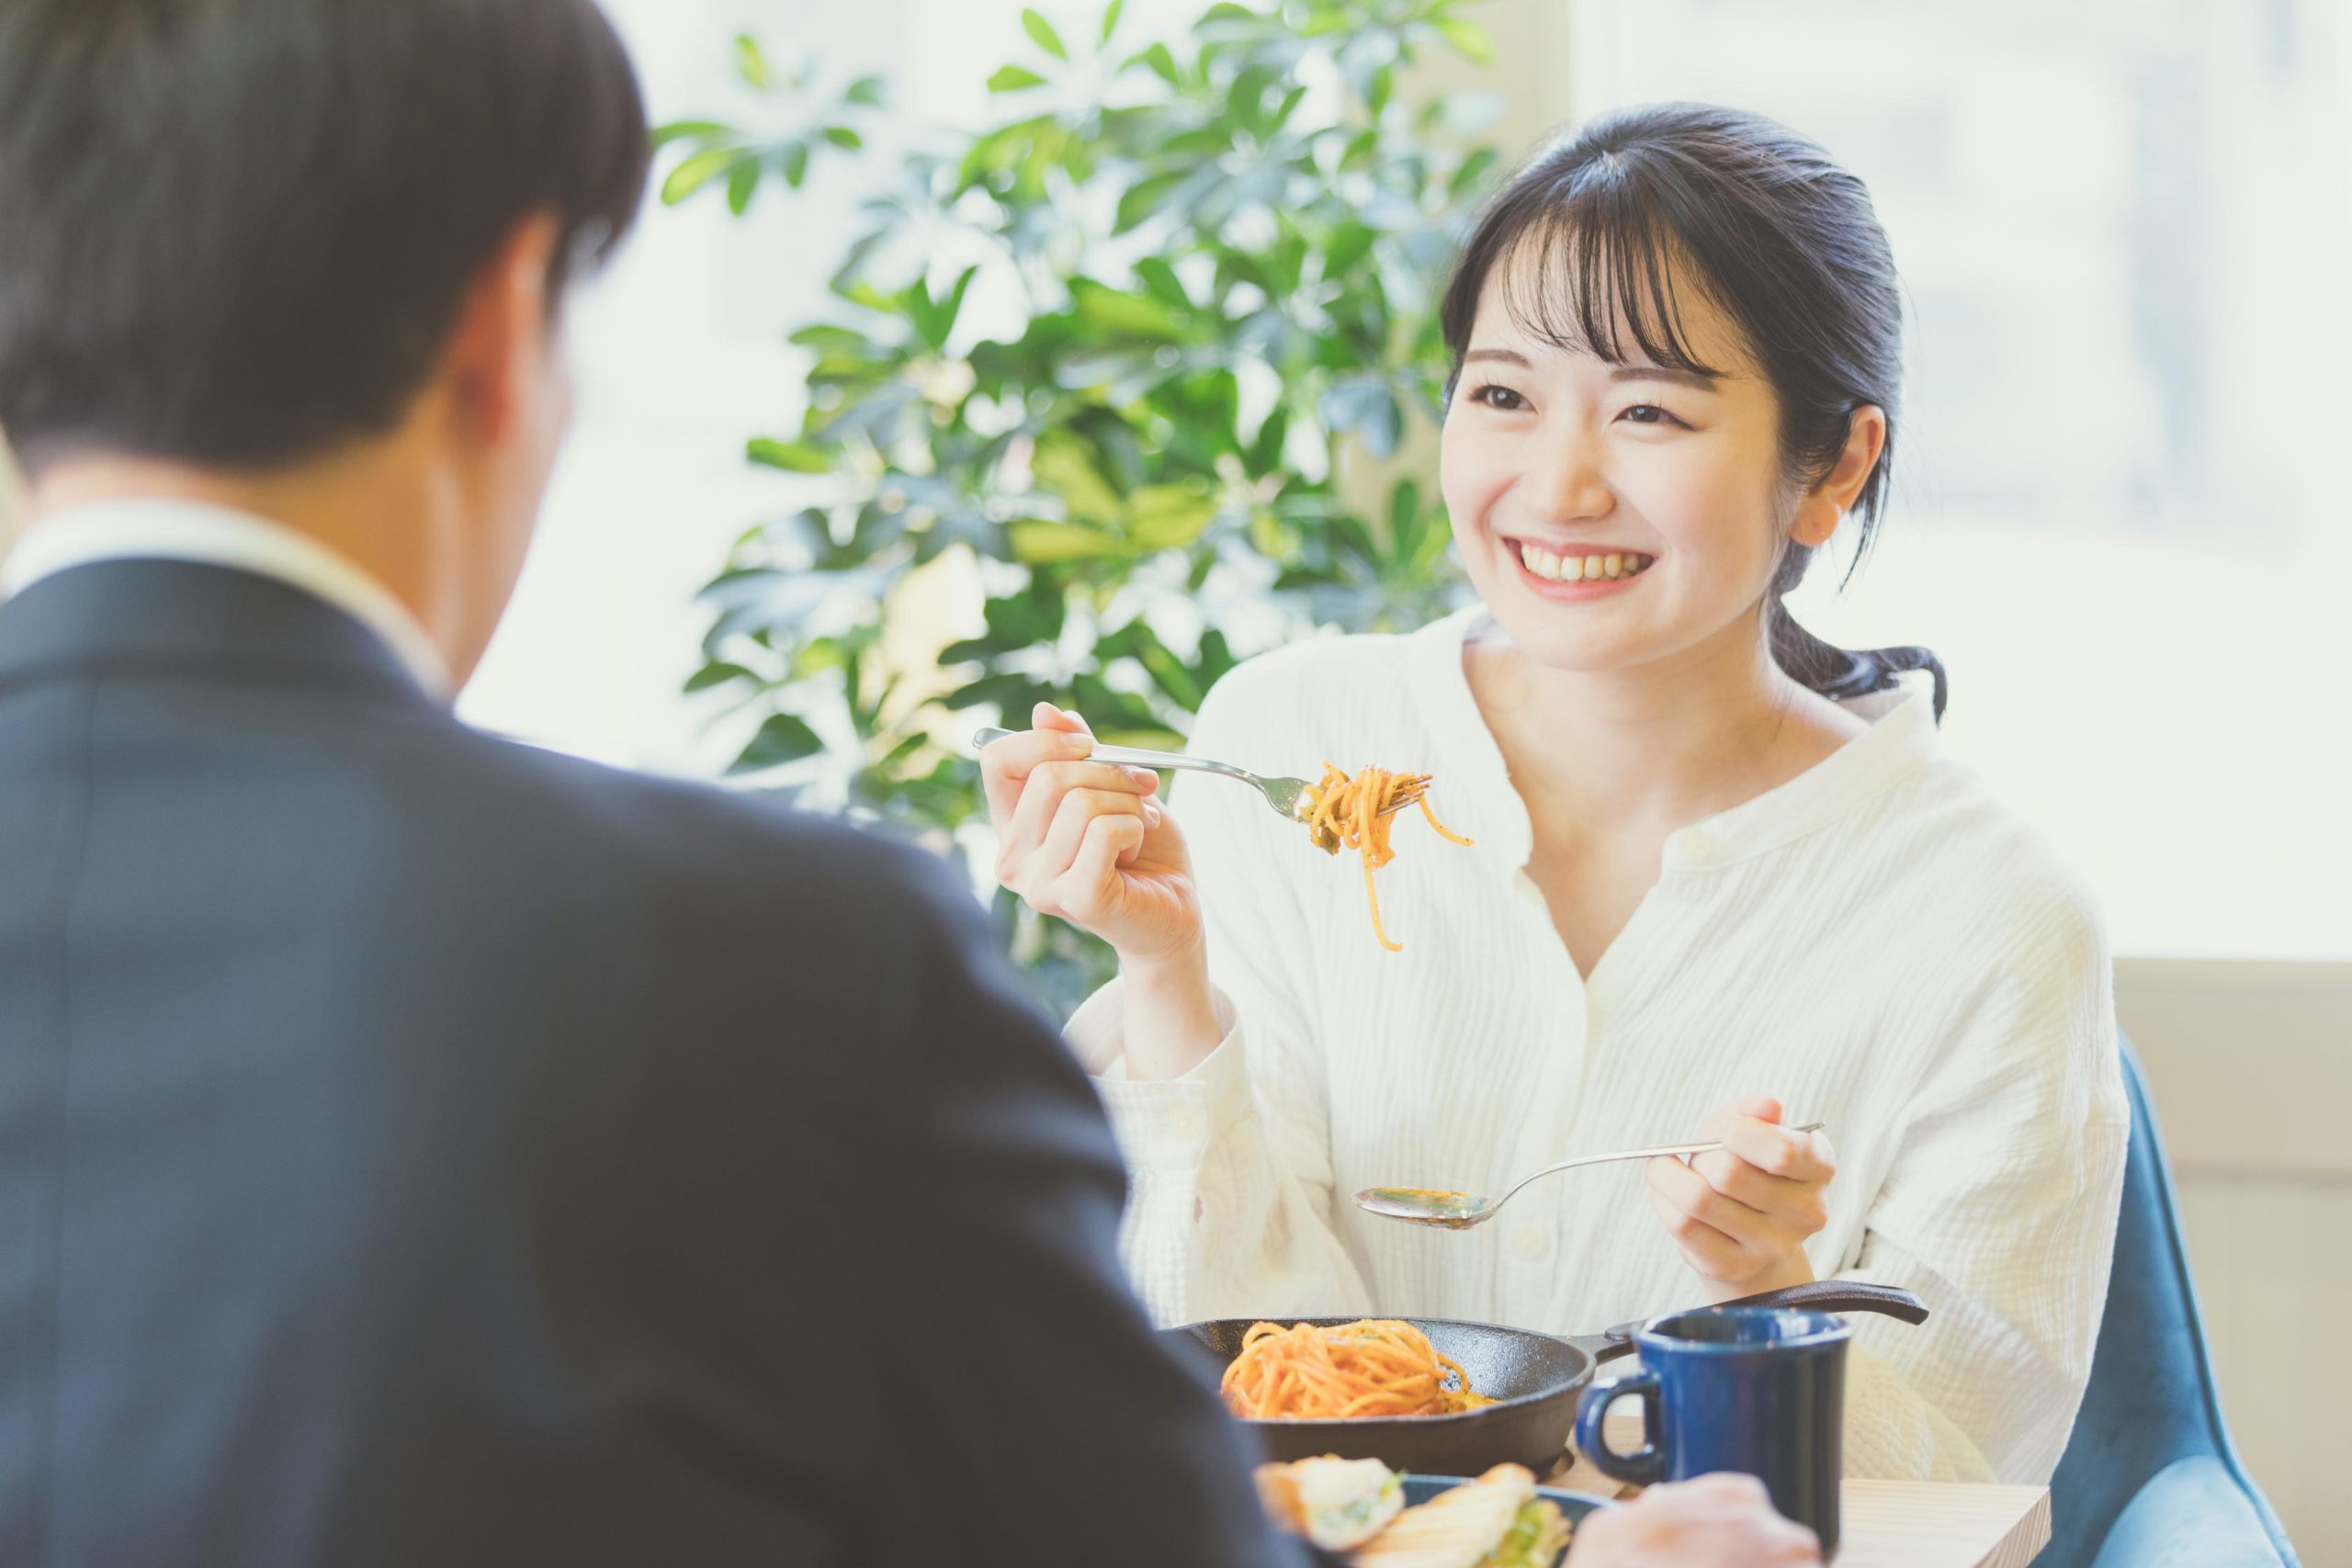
[0,496,457,701]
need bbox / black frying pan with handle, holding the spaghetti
[1167,1279,1927,1476]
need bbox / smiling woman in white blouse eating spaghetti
[983,106,2126,1481]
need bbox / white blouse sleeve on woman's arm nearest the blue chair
[1841,882,2131,1483]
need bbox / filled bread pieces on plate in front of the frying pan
[1259,1458,1569,1568]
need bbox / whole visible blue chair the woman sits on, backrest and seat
[2034,1039,2298,1568]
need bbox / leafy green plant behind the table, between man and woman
[661,0,1496,1006]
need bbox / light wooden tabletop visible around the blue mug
[1547,1411,2051,1568]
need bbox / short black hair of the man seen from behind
[0,0,651,470]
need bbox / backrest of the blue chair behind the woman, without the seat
[2034,1039,2296,1568]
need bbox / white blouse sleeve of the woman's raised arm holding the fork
[1068,665,1371,1324]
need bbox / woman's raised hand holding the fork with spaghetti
[981,703,1202,978]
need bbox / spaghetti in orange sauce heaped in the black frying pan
[1221,1319,1494,1420]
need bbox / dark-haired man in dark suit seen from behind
[0,0,1815,1568]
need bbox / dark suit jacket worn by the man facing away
[0,562,1303,1568]
